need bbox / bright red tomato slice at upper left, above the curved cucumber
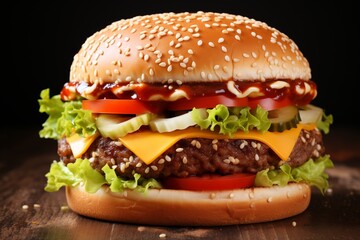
[82,99,165,114]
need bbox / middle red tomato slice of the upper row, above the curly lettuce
[168,95,248,111]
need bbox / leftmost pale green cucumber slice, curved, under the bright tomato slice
[96,113,154,140]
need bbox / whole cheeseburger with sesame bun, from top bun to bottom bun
[39,11,333,226]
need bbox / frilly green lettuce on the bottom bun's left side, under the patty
[45,158,161,193]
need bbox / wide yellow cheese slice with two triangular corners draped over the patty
[120,124,315,164]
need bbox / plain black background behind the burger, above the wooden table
[8,0,360,129]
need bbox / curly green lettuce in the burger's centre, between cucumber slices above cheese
[192,104,271,135]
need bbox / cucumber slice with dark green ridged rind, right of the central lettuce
[268,106,300,132]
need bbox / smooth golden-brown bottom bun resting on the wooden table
[66,183,311,226]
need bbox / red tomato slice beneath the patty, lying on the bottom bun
[162,173,256,191]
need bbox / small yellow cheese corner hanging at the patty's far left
[66,133,99,158]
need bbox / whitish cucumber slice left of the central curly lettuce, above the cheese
[150,109,206,133]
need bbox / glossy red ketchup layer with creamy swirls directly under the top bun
[60,79,317,106]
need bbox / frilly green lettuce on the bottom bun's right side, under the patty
[255,155,334,194]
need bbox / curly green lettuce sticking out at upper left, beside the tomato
[38,89,97,139]
